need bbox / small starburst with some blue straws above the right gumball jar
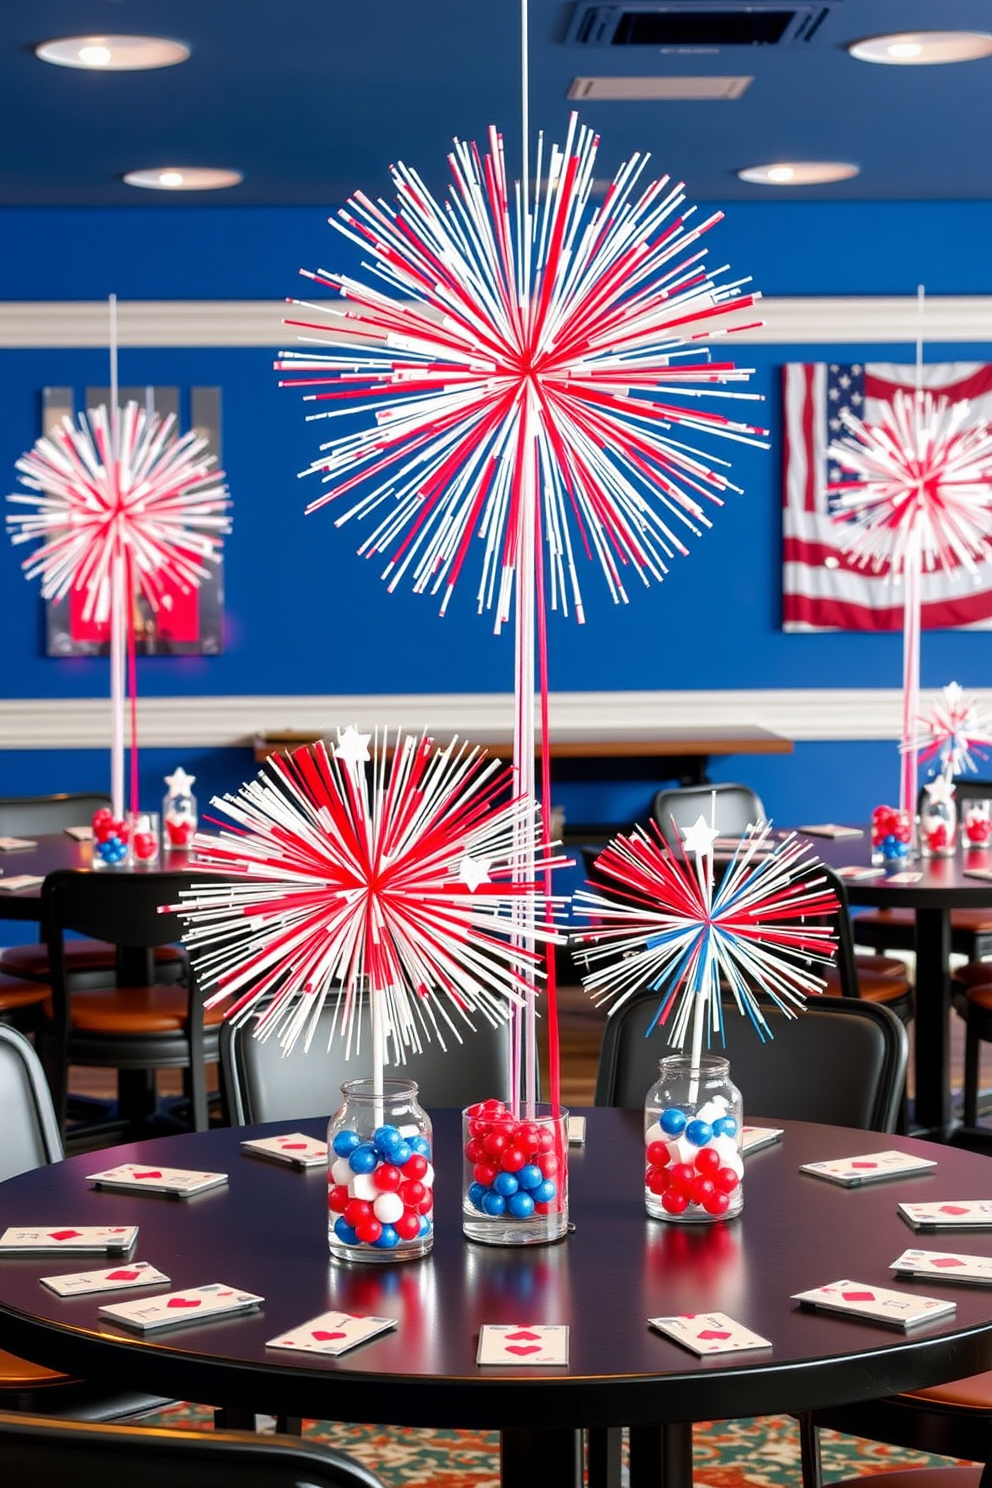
[573,818,839,1058]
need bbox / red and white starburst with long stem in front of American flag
[828,390,992,814]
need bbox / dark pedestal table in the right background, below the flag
[809,827,992,1137]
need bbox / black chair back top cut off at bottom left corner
[0,1414,382,1488]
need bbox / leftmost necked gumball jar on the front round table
[327,1079,434,1263]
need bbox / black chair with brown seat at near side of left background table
[42,869,223,1131]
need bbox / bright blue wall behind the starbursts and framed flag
[0,202,992,820]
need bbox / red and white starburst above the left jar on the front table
[178,728,564,1076]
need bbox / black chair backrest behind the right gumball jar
[596,988,909,1131]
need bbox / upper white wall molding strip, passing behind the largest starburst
[0,295,992,351]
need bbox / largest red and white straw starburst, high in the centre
[277,116,766,631]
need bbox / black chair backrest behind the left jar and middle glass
[220,1006,510,1126]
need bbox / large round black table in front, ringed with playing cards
[0,1110,992,1488]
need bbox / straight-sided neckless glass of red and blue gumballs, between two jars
[461,1100,568,1245]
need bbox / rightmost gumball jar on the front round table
[644,1055,744,1225]
